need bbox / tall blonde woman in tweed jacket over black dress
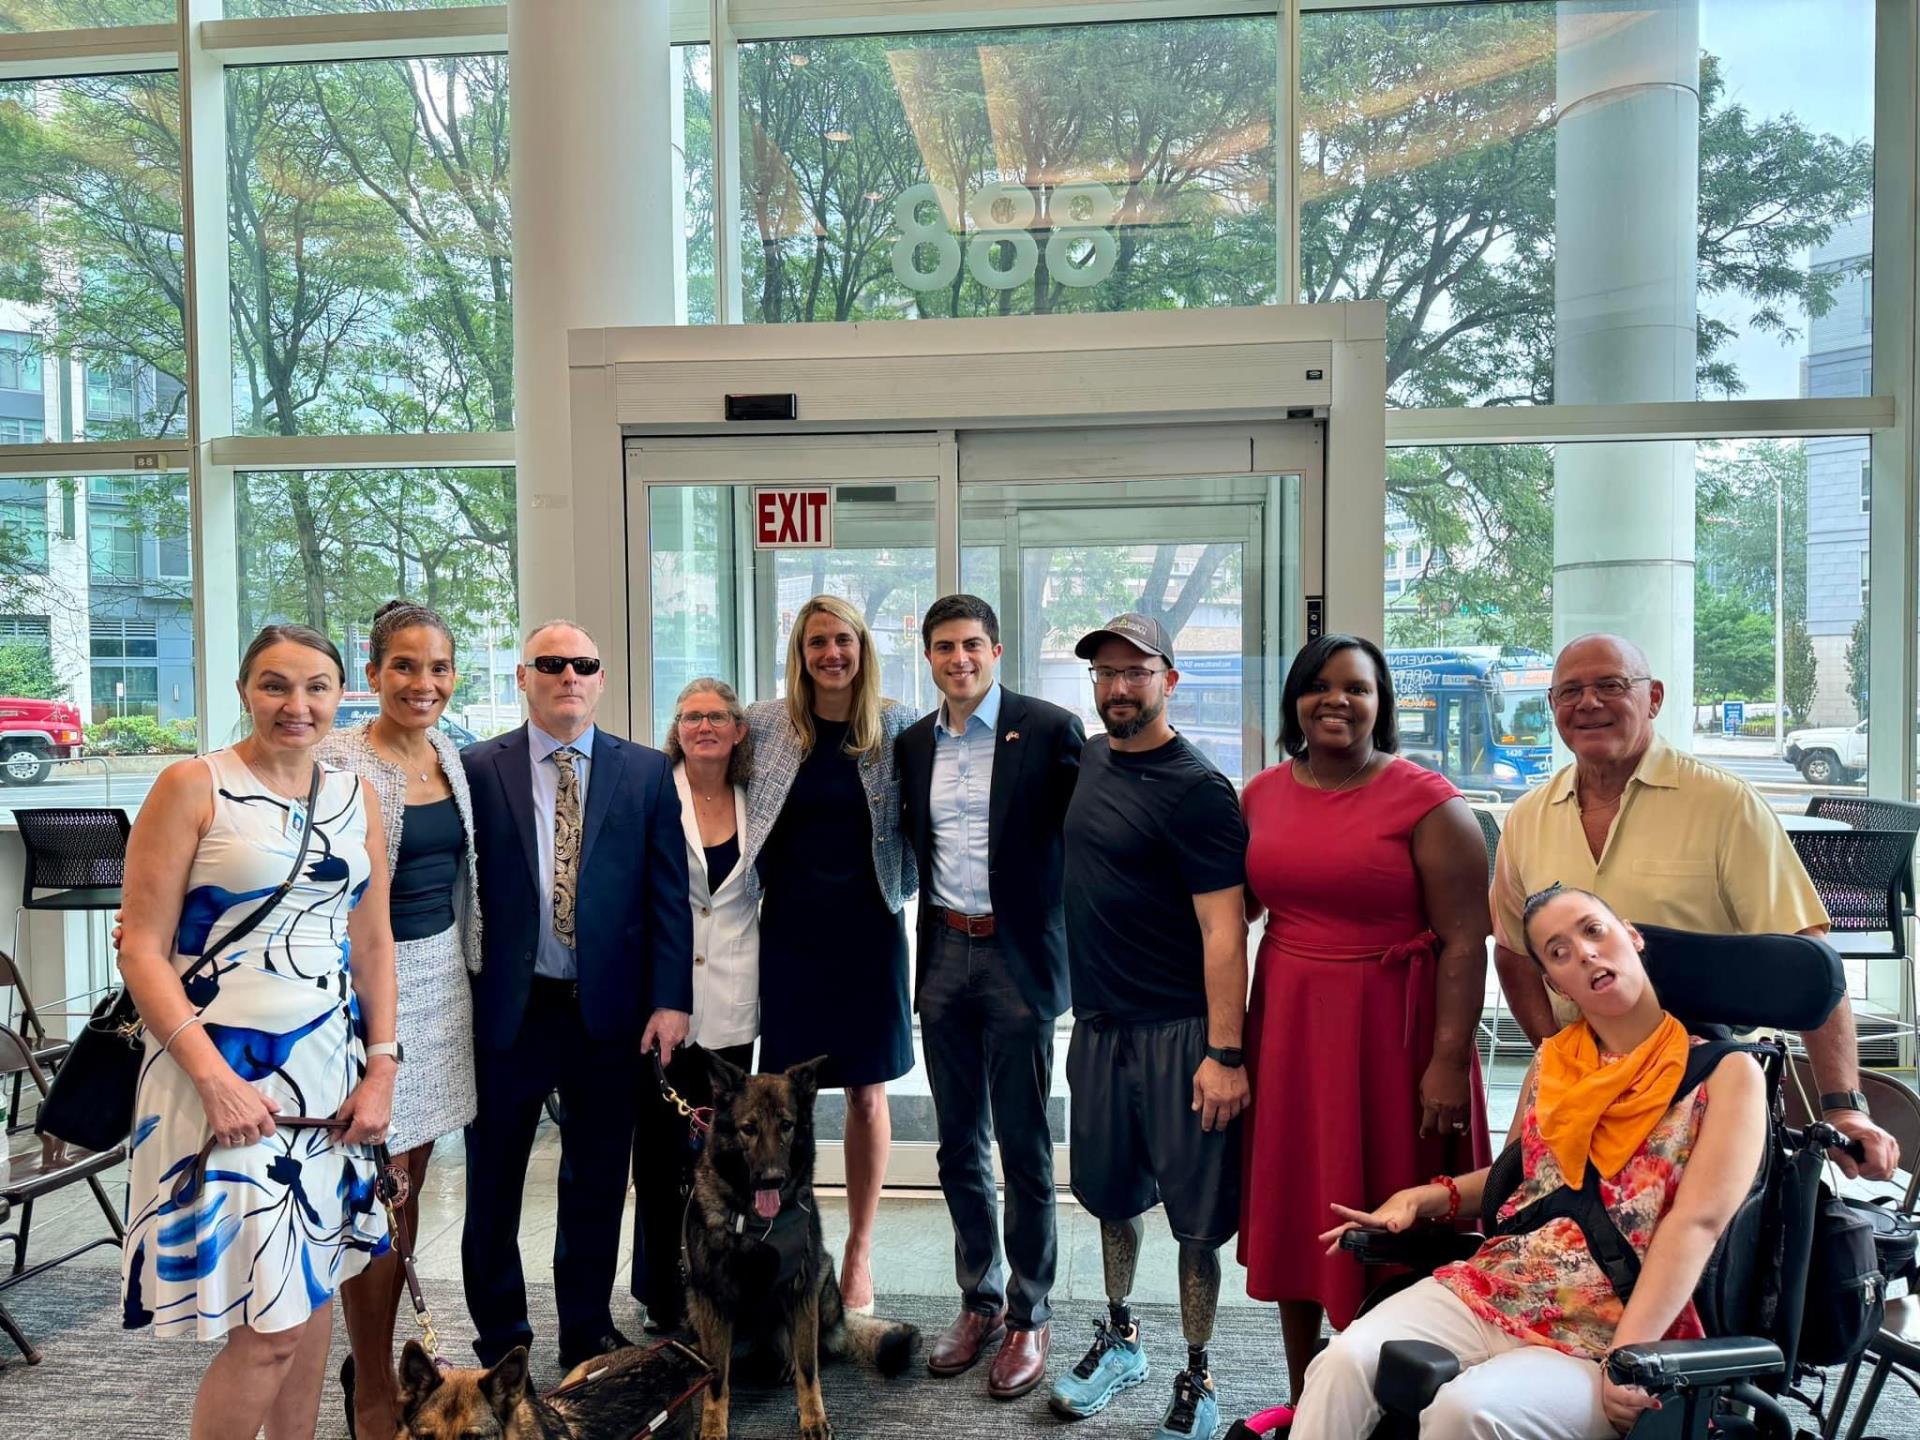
[741,595,918,1309]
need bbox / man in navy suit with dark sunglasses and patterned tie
[461,620,693,1367]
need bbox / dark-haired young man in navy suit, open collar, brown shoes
[895,595,1085,1400]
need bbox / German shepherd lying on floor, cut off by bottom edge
[399,1340,708,1440]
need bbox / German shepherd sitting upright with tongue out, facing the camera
[684,1054,916,1440]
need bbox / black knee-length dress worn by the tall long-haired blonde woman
[760,714,914,1087]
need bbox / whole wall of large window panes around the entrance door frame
[0,0,1904,814]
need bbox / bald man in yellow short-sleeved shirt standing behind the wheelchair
[1494,636,1899,1179]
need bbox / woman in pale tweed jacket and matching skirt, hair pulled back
[321,601,480,1440]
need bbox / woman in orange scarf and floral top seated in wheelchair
[1288,885,1766,1440]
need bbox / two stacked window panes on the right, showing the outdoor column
[1298,0,1874,808]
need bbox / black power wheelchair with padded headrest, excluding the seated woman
[1313,925,1878,1440]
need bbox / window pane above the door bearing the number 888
[739,15,1281,324]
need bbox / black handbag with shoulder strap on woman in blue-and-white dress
[33,766,321,1150]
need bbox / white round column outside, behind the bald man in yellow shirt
[1553,0,1699,749]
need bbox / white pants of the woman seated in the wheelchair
[1288,1279,1615,1440]
